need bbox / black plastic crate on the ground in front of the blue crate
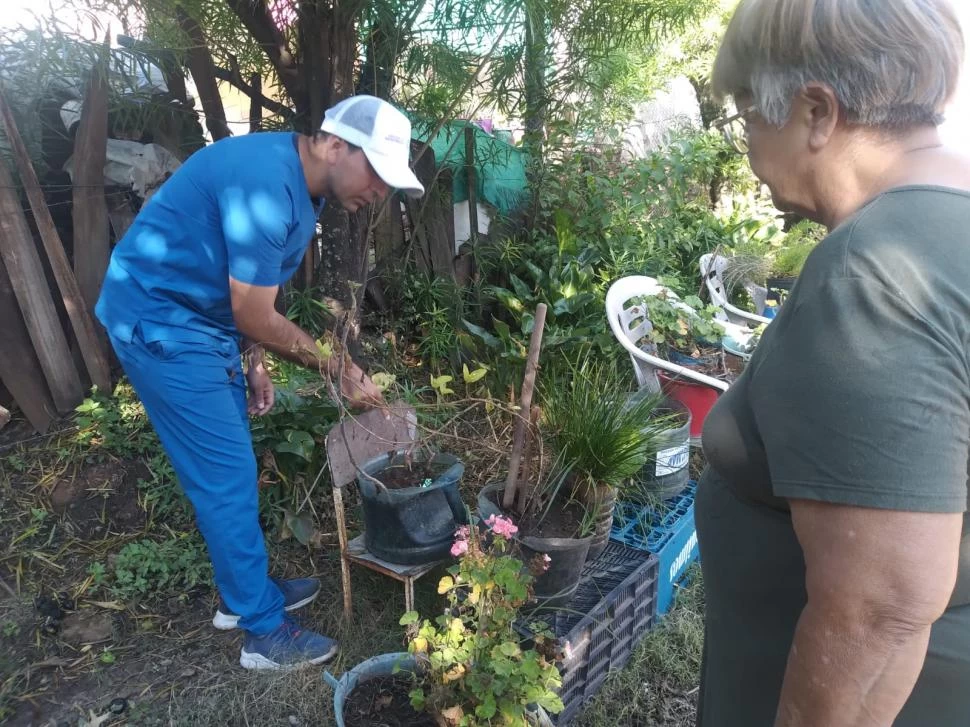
[516,542,658,727]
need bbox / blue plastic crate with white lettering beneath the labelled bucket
[610,482,697,616]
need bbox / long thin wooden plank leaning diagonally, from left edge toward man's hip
[0,92,111,398]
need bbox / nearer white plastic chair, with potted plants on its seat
[606,275,728,392]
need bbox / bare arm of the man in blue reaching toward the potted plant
[229,277,382,404]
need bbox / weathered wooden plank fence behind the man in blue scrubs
[0,77,468,432]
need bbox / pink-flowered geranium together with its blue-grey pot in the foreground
[329,517,563,727]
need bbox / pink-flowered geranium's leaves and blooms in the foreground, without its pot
[401,515,563,727]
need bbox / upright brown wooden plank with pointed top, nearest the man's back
[72,53,111,328]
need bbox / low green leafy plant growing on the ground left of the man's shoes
[88,534,212,601]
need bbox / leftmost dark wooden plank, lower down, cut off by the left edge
[0,250,55,434]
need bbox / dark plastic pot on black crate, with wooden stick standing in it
[478,482,593,608]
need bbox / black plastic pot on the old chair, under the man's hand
[357,452,468,565]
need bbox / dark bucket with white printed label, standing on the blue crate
[620,399,691,502]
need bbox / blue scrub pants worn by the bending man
[111,329,283,636]
